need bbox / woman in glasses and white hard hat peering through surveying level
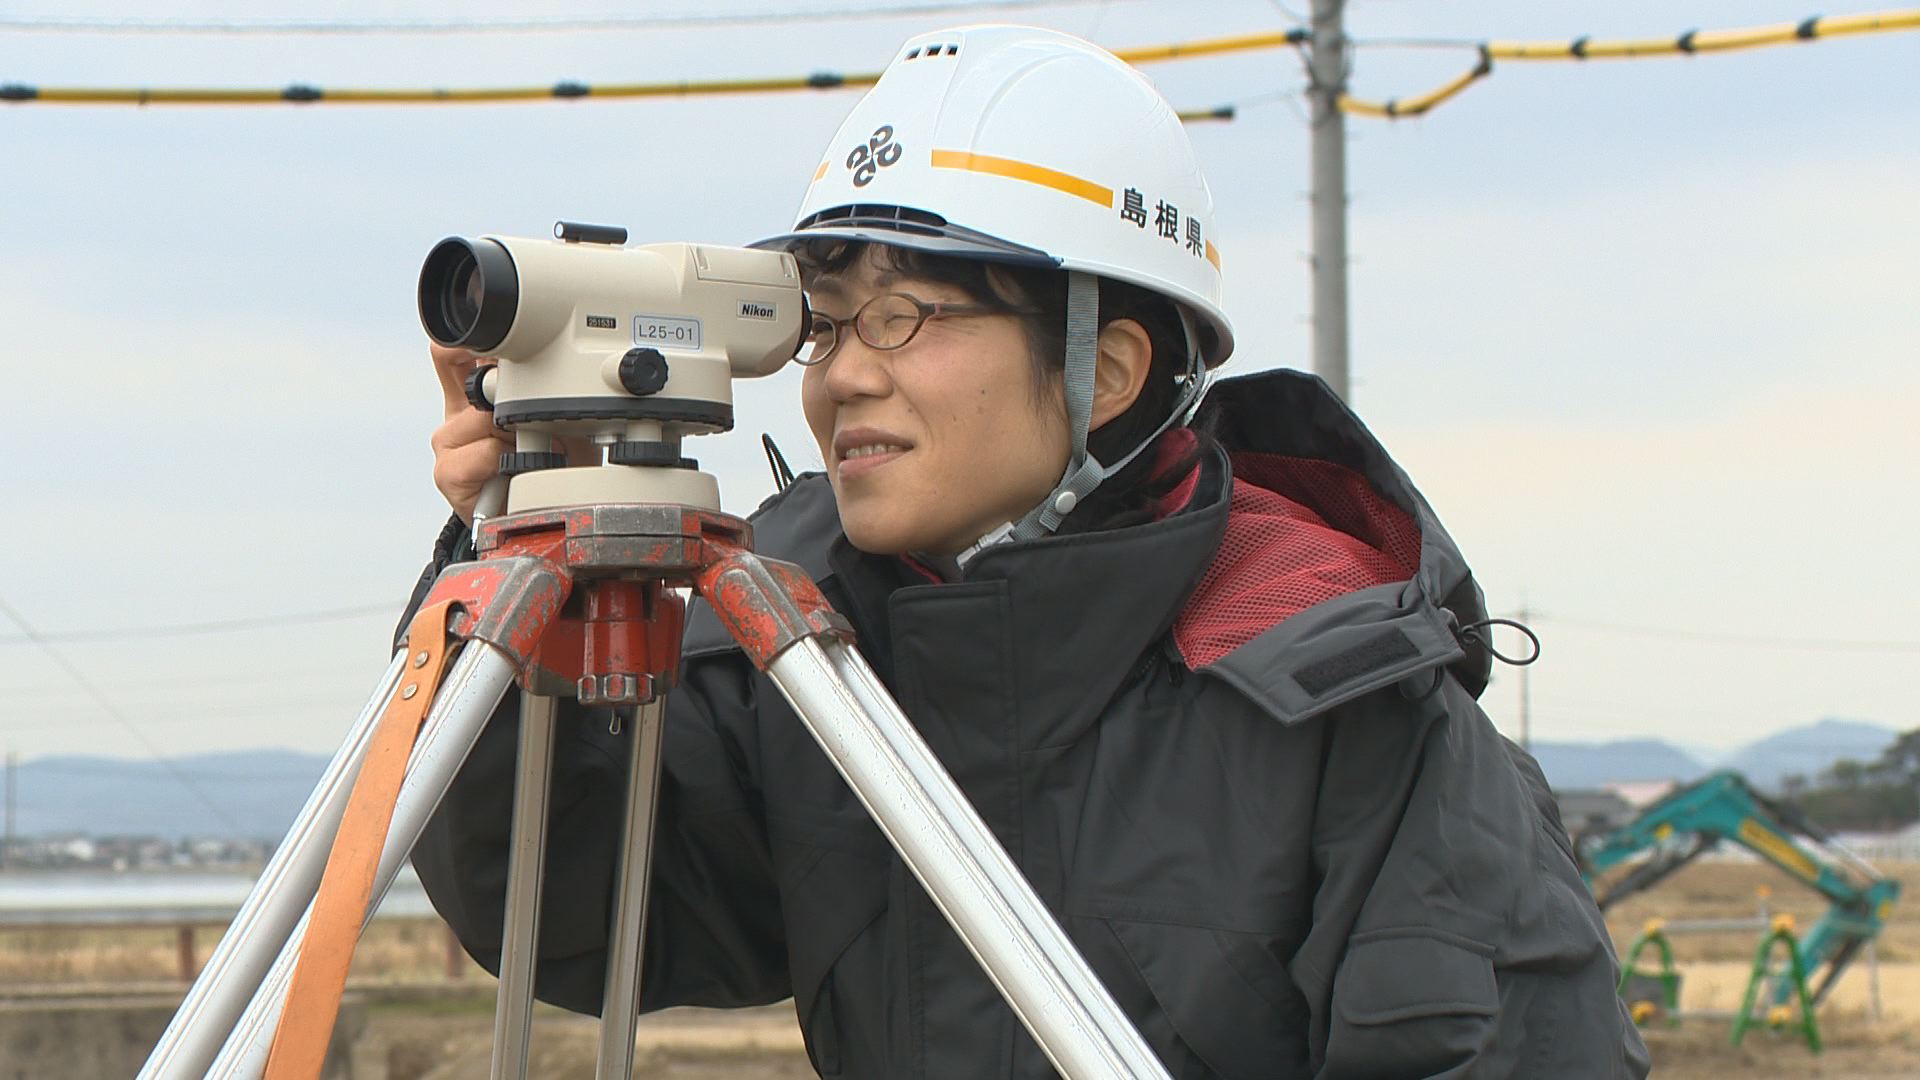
[415,27,1645,1078]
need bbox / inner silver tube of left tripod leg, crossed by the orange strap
[196,642,516,1080]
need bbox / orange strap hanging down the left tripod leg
[265,600,455,1080]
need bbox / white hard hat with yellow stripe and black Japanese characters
[756,25,1233,367]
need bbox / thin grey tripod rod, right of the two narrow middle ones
[593,694,666,1080]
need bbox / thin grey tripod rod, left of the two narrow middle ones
[492,694,555,1080]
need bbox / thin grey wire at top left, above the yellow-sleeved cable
[0,0,1094,35]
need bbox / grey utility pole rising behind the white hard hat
[1308,0,1352,402]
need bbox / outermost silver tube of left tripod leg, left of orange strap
[140,653,407,1080]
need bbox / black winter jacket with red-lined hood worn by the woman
[415,365,1647,1080]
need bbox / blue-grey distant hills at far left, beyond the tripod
[13,749,328,840]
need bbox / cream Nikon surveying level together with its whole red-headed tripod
[140,223,1167,1080]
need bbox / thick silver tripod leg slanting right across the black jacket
[766,638,1167,1080]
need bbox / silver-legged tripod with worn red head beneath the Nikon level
[140,466,1167,1080]
